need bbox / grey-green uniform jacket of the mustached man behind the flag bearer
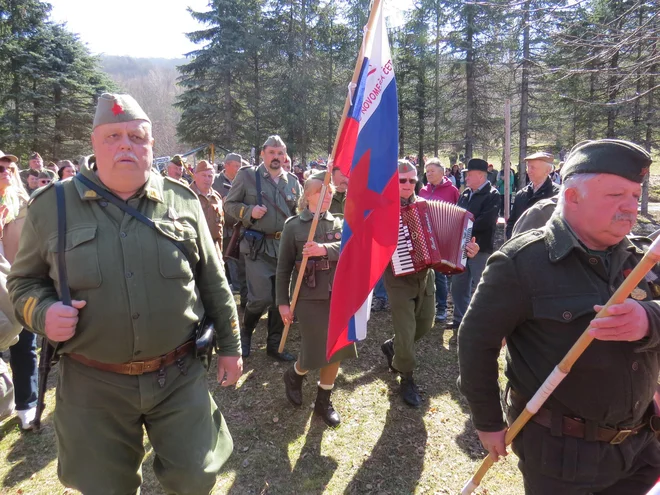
[224,163,300,258]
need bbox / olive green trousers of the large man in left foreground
[54,355,233,495]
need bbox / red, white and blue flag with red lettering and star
[326,3,399,359]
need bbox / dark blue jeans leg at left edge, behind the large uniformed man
[9,328,39,411]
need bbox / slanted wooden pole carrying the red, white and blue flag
[278,0,381,352]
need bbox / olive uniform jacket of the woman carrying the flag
[275,209,344,306]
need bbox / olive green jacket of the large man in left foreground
[7,167,240,363]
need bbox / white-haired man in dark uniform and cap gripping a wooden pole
[458,139,660,495]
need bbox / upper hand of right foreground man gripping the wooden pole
[589,299,649,342]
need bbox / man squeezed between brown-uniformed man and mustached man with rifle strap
[213,153,247,308]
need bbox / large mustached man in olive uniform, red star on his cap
[7,93,242,495]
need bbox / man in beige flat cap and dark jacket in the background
[506,152,559,239]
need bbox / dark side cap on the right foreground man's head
[561,139,653,183]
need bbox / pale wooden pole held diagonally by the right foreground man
[461,238,660,495]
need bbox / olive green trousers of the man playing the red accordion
[383,267,435,373]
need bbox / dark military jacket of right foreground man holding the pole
[458,216,660,431]
